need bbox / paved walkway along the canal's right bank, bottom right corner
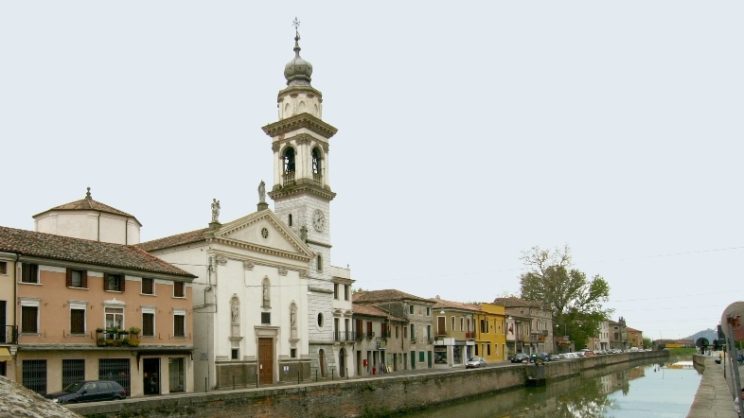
[687,355,738,418]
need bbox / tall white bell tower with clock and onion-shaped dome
[263,19,338,374]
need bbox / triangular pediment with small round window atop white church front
[214,209,315,260]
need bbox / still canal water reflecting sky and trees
[401,363,701,418]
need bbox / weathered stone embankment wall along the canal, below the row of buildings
[70,352,668,418]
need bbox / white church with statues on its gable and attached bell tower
[140,28,355,391]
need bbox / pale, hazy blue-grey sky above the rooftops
[0,0,744,339]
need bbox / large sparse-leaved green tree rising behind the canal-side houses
[520,247,611,348]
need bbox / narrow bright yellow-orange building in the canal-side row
[475,303,507,363]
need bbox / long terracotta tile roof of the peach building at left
[0,226,196,278]
